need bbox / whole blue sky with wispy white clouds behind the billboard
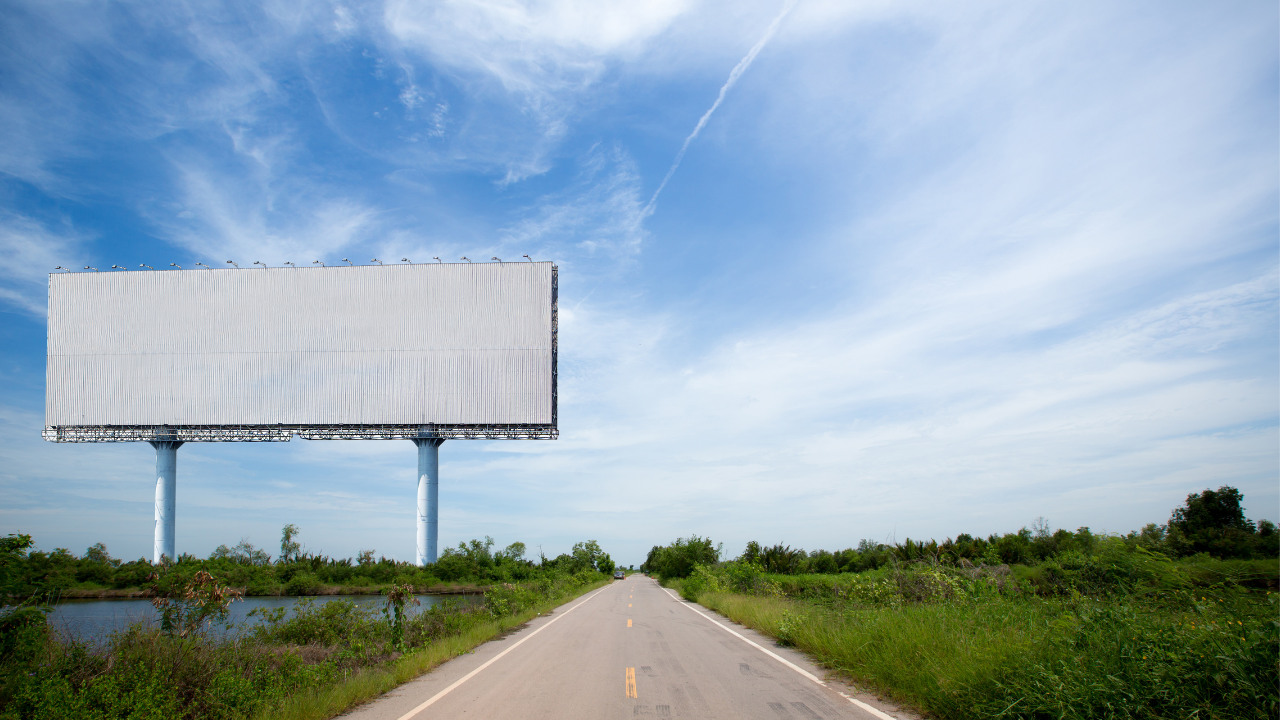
[0,0,1280,564]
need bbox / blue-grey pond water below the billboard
[49,594,481,641]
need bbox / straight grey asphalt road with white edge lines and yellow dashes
[343,575,906,720]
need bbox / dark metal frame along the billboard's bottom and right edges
[41,265,559,442]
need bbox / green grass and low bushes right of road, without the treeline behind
[668,539,1280,720]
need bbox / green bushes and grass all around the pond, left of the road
[0,536,612,720]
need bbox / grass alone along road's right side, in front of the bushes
[698,591,1280,720]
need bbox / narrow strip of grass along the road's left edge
[255,580,612,720]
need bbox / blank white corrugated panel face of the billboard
[45,263,553,427]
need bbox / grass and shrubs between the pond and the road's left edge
[0,573,607,720]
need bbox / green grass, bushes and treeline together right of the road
[643,486,1280,720]
